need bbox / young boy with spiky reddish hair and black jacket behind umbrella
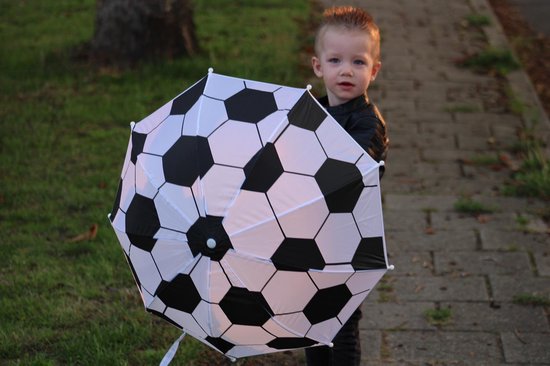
[306,6,388,366]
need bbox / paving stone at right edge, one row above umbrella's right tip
[479,227,550,253]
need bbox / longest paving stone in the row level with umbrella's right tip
[434,251,533,275]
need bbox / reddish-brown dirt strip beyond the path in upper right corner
[489,0,550,115]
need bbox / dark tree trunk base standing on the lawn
[91,0,199,65]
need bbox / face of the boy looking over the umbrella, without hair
[311,27,381,106]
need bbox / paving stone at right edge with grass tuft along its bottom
[489,274,550,302]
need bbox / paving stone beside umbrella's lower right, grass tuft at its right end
[359,302,436,330]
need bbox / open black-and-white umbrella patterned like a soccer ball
[110,70,388,358]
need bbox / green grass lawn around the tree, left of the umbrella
[0,0,309,365]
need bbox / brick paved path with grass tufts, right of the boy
[325,0,550,365]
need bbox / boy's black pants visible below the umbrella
[306,309,361,366]
